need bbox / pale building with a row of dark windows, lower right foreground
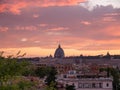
[57,71,113,90]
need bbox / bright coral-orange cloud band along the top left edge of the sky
[0,0,86,14]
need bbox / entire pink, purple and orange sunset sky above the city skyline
[0,0,120,57]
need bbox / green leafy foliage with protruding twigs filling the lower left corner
[0,52,35,90]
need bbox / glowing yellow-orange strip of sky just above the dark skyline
[0,47,120,57]
